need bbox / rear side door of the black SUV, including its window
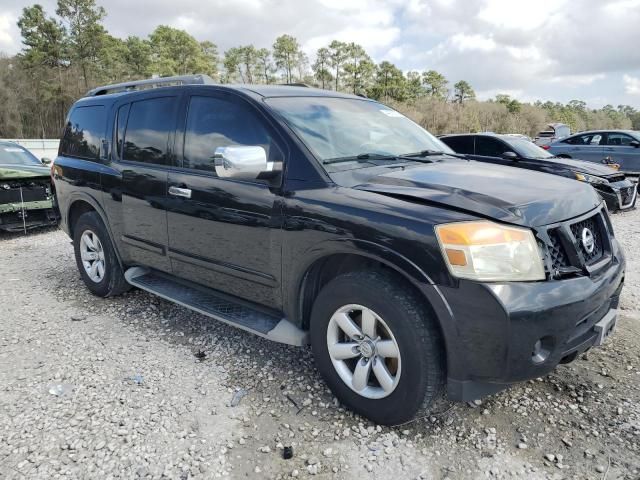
[116,94,179,272]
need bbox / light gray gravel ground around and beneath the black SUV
[0,211,640,480]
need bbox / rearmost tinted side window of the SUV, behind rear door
[60,105,106,160]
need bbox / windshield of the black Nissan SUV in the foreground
[266,97,454,167]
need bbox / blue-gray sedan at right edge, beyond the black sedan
[547,130,640,175]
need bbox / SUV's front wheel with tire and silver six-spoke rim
[311,271,445,425]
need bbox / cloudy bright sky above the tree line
[0,0,640,108]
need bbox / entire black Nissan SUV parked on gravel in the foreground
[53,76,625,424]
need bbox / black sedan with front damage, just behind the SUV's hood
[440,133,637,210]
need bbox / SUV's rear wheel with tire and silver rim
[73,212,131,297]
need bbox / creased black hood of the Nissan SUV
[354,157,601,227]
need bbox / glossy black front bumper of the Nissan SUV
[440,240,625,401]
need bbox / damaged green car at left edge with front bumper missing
[0,142,56,232]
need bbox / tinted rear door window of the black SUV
[123,97,177,165]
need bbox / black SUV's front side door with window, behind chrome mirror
[168,92,284,307]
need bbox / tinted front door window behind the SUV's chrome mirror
[183,97,283,172]
